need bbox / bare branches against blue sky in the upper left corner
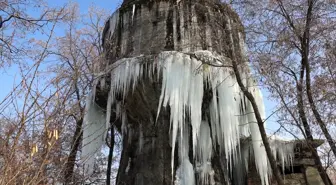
[0,0,67,66]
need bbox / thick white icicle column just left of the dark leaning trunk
[209,68,240,164]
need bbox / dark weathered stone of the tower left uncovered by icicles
[96,0,244,185]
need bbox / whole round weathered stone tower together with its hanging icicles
[84,0,322,185]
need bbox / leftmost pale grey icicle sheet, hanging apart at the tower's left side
[82,95,106,174]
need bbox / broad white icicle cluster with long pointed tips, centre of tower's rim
[154,52,203,176]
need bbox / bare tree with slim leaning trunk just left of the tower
[51,6,107,183]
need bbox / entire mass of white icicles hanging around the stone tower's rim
[82,51,293,185]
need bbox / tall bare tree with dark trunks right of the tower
[231,0,336,184]
